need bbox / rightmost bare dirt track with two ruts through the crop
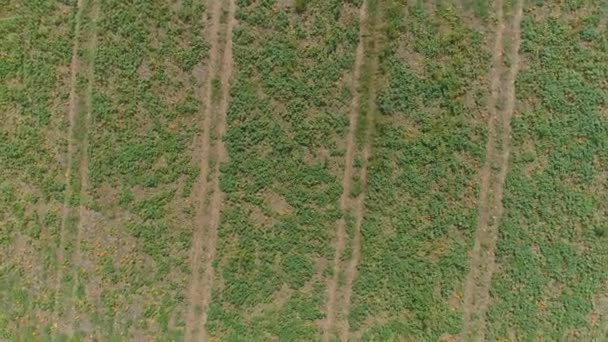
[463,0,523,341]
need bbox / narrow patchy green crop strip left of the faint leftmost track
[0,1,74,340]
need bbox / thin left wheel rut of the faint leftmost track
[53,0,84,330]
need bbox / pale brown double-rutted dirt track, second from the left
[186,0,236,341]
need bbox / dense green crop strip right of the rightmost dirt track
[488,1,608,341]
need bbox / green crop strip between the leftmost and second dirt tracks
[81,1,208,338]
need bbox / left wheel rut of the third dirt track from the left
[323,1,367,342]
